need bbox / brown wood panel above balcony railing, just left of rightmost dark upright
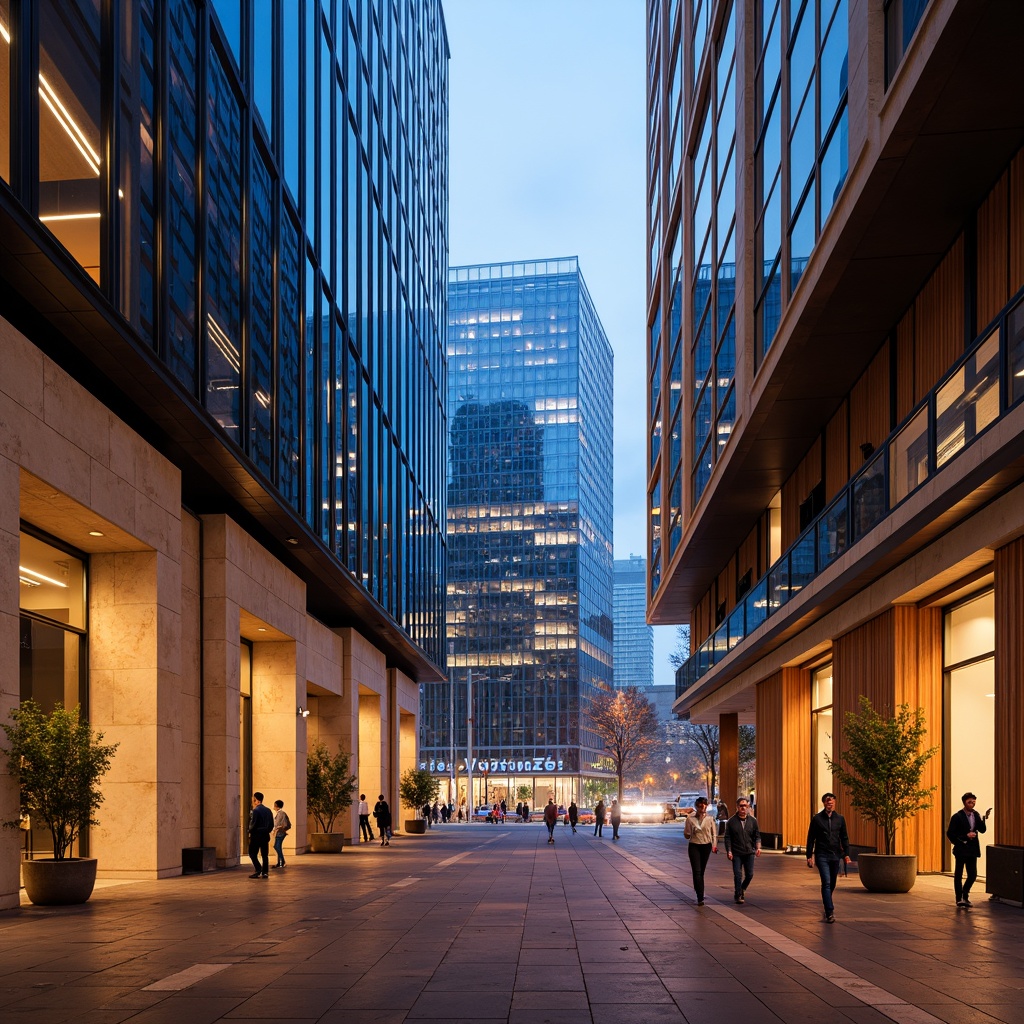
[914,234,965,402]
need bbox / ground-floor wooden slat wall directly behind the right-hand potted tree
[833,605,943,871]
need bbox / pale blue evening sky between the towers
[443,0,675,684]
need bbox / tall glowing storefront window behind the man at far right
[943,591,995,872]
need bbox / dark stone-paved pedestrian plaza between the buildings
[0,823,1024,1024]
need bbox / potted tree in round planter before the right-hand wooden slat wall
[825,695,938,893]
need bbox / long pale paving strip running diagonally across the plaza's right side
[598,847,942,1024]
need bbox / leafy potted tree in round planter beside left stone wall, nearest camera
[0,700,118,906]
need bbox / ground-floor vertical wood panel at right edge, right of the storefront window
[993,540,1024,846]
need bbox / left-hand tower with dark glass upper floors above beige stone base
[0,0,447,906]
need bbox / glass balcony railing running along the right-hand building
[676,293,1024,697]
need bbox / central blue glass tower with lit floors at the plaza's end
[421,259,612,805]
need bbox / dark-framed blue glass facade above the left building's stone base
[0,0,447,664]
